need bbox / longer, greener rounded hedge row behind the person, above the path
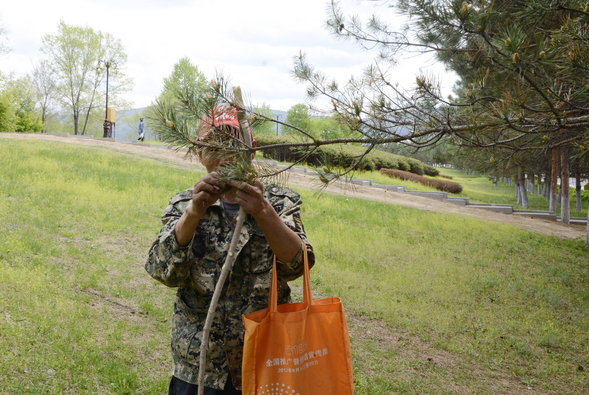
[256,135,439,176]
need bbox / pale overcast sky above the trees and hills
[0,0,454,111]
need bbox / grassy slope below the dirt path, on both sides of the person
[0,139,589,395]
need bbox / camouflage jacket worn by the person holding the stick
[145,185,315,389]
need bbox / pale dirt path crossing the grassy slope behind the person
[0,133,586,239]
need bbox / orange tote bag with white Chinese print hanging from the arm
[242,243,354,395]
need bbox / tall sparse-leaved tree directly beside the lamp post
[41,21,133,134]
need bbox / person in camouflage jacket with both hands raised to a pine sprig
[145,106,314,394]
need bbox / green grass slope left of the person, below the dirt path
[0,139,198,394]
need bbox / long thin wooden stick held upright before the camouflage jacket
[198,86,252,395]
